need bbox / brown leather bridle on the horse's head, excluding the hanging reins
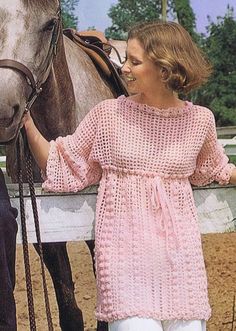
[0,9,61,115]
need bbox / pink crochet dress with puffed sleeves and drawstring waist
[44,96,234,322]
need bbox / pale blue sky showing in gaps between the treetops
[75,0,236,33]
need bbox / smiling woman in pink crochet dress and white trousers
[22,22,236,331]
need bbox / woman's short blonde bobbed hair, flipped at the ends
[128,21,212,93]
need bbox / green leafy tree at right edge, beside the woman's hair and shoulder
[195,8,236,126]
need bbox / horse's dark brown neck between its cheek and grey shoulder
[32,34,77,140]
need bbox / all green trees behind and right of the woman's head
[105,0,236,126]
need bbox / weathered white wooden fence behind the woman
[3,130,236,243]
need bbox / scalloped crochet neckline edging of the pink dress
[117,95,193,117]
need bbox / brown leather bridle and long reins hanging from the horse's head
[0,5,61,331]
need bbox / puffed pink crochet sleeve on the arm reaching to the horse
[43,107,102,192]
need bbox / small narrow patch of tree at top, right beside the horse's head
[61,0,79,29]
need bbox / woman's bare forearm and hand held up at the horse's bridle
[23,113,50,172]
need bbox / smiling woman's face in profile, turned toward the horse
[122,39,164,94]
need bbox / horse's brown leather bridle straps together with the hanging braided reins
[0,9,61,331]
